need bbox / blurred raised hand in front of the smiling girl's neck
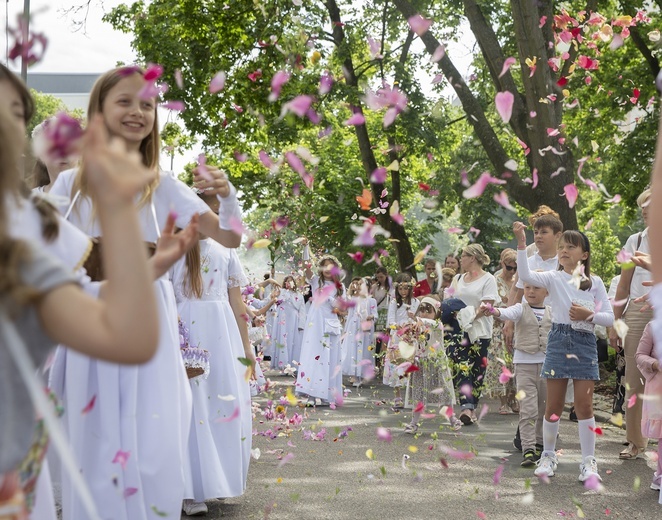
[82,115,156,206]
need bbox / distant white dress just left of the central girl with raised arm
[271,289,305,370]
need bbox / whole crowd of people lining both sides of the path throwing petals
[0,54,662,520]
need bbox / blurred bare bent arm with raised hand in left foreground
[37,117,158,363]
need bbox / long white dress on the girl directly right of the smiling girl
[173,239,252,502]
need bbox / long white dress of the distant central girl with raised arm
[296,276,344,402]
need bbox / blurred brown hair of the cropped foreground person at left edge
[0,107,37,305]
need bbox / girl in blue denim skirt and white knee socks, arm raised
[513,222,614,482]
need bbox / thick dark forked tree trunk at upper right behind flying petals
[394,0,577,229]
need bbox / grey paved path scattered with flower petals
[192,374,662,520]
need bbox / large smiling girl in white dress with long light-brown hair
[51,67,241,520]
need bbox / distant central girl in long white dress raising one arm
[296,244,345,406]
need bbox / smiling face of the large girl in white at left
[101,74,156,149]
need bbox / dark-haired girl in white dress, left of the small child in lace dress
[384,273,420,408]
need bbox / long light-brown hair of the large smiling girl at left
[71,67,160,207]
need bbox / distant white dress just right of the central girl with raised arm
[341,296,377,377]
